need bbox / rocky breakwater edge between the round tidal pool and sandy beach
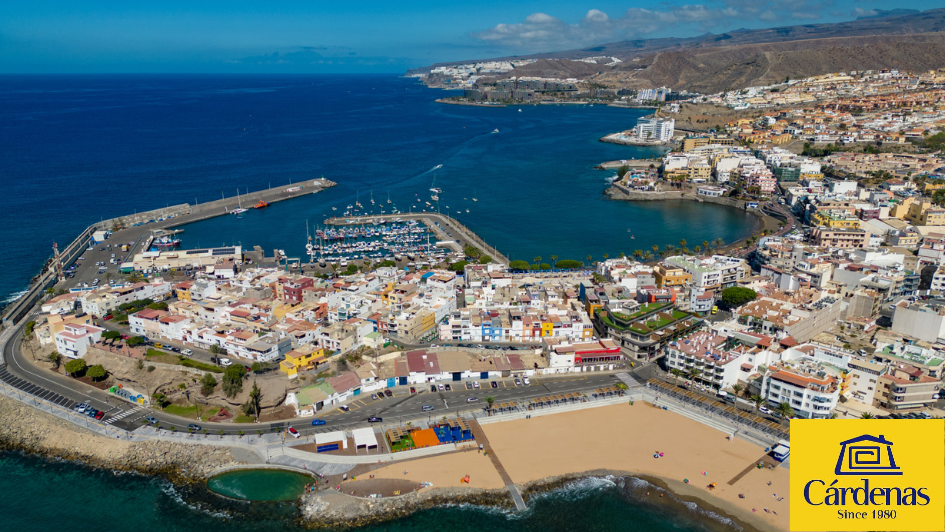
[299,488,514,529]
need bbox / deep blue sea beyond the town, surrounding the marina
[0,75,754,301]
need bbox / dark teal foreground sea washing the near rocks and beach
[0,452,737,532]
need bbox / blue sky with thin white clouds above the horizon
[0,0,942,73]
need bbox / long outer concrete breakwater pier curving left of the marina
[2,178,336,326]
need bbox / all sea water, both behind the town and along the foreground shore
[0,75,754,532]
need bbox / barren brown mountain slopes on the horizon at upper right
[417,9,945,93]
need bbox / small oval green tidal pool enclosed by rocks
[207,469,312,501]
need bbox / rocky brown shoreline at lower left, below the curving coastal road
[0,390,238,482]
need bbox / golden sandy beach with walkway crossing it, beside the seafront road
[374,402,789,530]
